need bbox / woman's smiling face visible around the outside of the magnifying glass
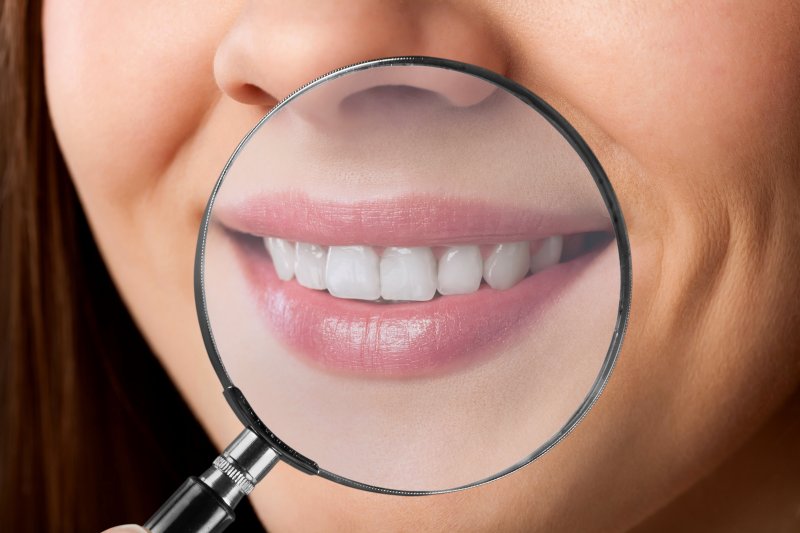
[43,0,800,530]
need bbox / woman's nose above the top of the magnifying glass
[214,0,507,107]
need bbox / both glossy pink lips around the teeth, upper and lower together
[214,194,612,378]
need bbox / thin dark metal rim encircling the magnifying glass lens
[194,56,632,496]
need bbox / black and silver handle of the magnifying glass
[144,428,278,533]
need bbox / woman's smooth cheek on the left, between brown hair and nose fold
[42,0,232,205]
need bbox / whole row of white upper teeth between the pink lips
[264,235,563,301]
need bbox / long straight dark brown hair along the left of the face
[0,0,260,532]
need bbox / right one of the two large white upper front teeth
[381,246,436,302]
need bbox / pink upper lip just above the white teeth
[212,191,611,246]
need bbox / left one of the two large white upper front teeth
[325,246,381,300]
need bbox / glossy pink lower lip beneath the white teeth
[237,239,611,378]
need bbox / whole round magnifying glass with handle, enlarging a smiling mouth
[146,57,631,533]
